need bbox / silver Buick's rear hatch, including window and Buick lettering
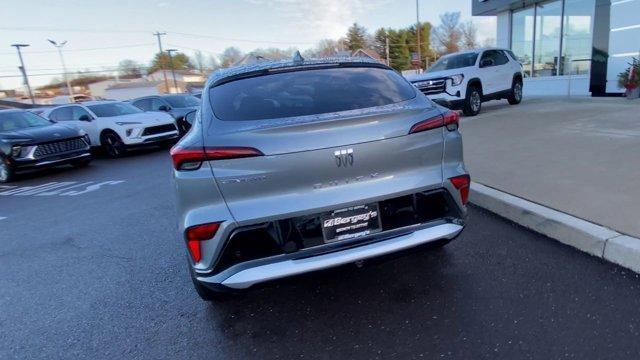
[203,67,443,225]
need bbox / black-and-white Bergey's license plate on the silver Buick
[320,203,382,243]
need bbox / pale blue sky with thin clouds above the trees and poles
[0,0,495,89]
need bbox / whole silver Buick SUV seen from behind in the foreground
[171,55,470,300]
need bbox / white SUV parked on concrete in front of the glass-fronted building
[407,49,523,116]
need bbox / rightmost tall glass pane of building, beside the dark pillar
[560,0,595,75]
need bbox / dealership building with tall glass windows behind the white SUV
[472,0,640,96]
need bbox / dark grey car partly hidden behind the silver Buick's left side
[130,94,200,135]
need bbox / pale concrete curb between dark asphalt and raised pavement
[469,182,640,273]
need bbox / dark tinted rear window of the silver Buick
[210,68,416,121]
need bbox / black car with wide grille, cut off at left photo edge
[0,110,91,183]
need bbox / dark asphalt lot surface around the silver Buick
[0,150,640,359]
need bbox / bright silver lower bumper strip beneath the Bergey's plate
[197,222,464,289]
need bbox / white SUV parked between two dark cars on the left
[43,101,178,157]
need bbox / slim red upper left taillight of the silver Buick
[170,145,264,171]
